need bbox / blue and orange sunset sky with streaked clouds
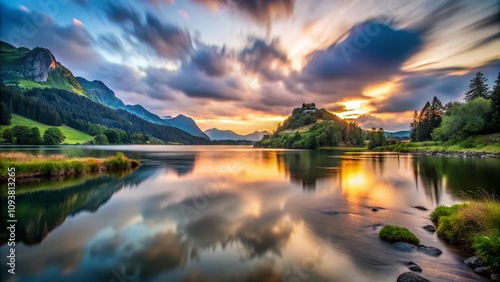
[0,0,500,134]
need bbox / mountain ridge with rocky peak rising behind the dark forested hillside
[0,41,209,139]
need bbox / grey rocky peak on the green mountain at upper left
[22,47,60,82]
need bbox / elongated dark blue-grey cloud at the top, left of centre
[106,4,193,59]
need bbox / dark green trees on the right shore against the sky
[410,72,500,142]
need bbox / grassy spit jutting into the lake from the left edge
[0,152,140,179]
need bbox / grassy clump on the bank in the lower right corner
[431,199,500,271]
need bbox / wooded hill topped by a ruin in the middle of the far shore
[255,104,364,149]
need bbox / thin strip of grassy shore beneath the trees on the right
[374,133,500,154]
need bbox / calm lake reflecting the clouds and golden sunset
[0,145,500,282]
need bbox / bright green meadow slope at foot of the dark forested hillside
[0,114,93,144]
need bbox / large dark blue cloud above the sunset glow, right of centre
[303,21,423,82]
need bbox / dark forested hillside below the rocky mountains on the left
[0,85,209,144]
